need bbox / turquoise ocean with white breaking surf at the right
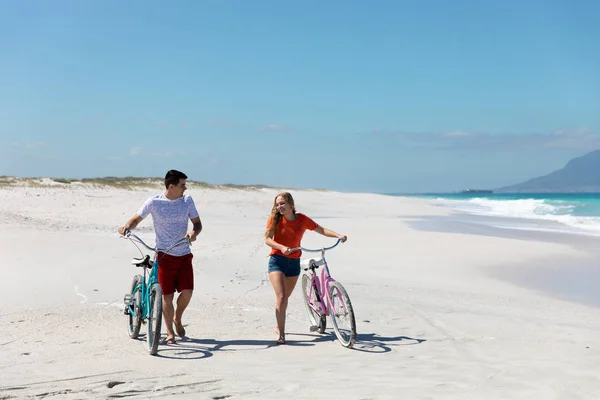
[397,193,600,236]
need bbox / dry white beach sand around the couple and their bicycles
[0,184,600,400]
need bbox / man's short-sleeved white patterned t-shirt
[137,194,198,256]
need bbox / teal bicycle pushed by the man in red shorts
[122,231,191,355]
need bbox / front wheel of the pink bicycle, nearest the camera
[329,282,356,348]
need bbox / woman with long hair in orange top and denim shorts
[265,192,347,344]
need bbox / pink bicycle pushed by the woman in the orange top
[292,239,356,348]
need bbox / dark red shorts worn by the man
[158,252,194,295]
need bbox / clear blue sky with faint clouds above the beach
[0,0,600,192]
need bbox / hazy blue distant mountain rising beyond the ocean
[494,150,600,193]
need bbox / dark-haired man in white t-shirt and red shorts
[119,169,202,344]
